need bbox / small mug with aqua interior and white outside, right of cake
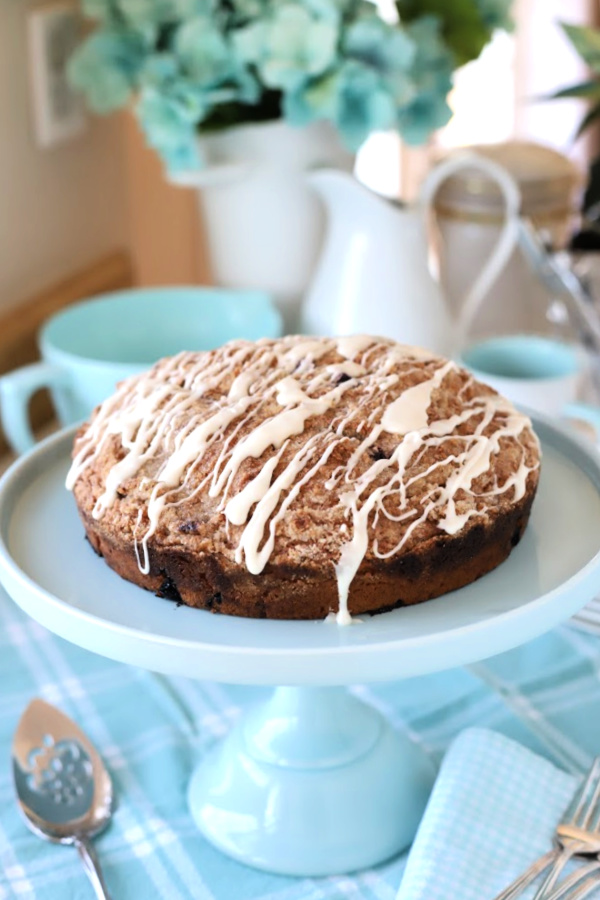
[459,334,600,435]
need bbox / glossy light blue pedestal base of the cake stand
[189,687,435,876]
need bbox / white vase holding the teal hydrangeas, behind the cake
[171,121,354,331]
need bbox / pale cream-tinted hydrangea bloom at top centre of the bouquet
[234,3,338,90]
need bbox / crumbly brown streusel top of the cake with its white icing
[67,335,539,623]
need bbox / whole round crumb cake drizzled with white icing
[67,335,540,623]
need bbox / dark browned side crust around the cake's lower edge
[79,490,534,619]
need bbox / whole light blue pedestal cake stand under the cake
[0,419,600,875]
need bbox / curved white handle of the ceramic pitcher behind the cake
[421,151,521,353]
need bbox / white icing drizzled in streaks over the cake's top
[67,335,537,624]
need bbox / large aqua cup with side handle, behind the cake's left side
[0,287,282,453]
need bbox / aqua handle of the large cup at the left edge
[0,362,69,454]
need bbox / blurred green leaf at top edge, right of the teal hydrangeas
[396,0,490,66]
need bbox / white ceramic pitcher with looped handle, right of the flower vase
[302,153,521,355]
